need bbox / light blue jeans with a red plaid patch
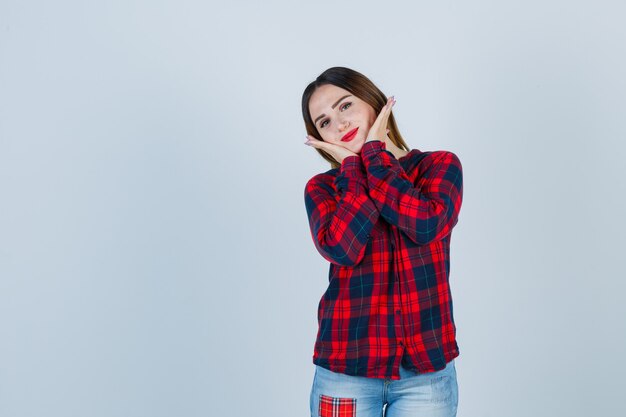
[310,359,458,417]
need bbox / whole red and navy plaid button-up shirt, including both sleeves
[304,140,463,379]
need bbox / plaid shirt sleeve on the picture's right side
[361,140,463,245]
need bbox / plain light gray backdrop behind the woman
[0,0,626,417]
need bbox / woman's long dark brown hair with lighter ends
[302,67,410,168]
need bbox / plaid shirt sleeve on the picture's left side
[304,155,379,266]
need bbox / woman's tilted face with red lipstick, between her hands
[309,84,376,154]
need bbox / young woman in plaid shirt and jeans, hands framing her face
[302,67,463,417]
